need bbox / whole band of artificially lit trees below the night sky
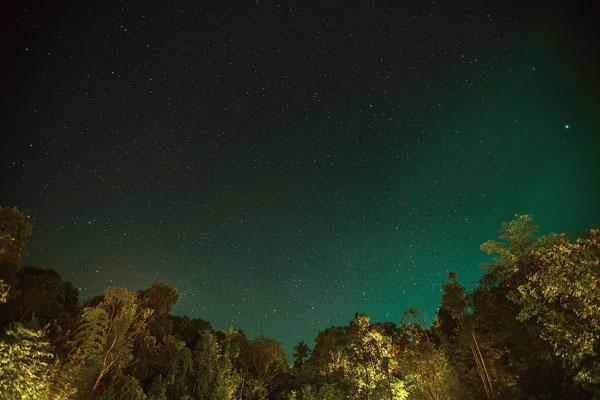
[0,208,600,400]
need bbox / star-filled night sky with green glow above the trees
[0,0,600,351]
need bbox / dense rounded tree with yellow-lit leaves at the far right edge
[514,229,600,388]
